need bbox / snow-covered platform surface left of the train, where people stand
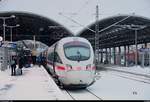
[0,66,67,100]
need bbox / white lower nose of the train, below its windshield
[61,66,95,86]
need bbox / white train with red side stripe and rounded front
[46,37,96,88]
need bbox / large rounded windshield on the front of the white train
[64,41,90,61]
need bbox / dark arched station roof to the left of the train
[0,12,73,46]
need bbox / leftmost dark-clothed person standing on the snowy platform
[10,56,17,76]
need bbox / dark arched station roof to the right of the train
[78,15,150,48]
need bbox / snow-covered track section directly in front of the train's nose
[63,89,102,100]
